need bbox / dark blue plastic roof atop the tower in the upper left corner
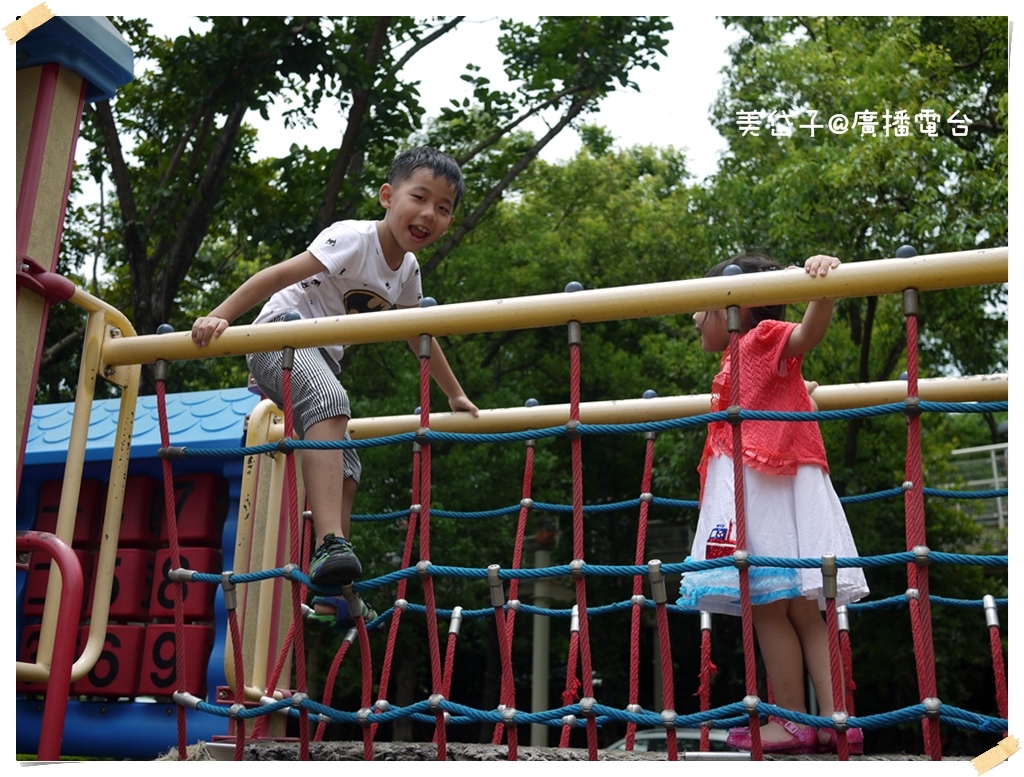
[16,16,135,102]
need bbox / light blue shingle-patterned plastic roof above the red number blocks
[25,388,260,466]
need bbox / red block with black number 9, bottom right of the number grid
[138,623,213,698]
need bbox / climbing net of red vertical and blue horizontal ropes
[148,280,1008,761]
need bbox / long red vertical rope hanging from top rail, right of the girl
[903,314,942,761]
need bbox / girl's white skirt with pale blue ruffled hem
[677,456,868,615]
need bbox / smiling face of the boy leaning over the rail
[380,167,455,252]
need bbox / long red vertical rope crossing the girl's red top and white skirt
[729,332,764,761]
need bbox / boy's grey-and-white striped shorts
[246,348,362,482]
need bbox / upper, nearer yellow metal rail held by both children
[103,248,1010,366]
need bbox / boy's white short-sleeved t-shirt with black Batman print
[253,221,423,373]
